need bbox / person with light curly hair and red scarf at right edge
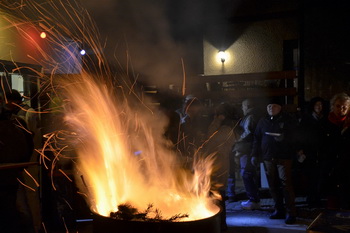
[322,93,350,209]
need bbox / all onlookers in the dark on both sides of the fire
[0,87,350,232]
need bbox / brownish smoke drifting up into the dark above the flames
[83,0,191,88]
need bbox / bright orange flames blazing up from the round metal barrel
[62,74,218,220]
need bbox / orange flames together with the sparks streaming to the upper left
[0,1,219,226]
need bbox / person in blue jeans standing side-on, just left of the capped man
[233,99,260,210]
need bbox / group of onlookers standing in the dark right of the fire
[164,93,350,229]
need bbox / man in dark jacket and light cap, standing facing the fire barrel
[252,98,297,224]
